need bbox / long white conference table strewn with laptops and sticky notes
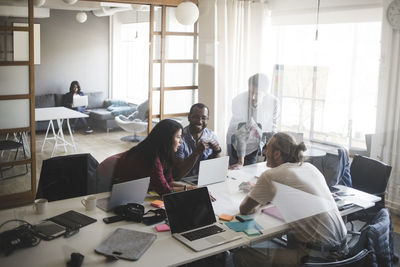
[0,162,380,267]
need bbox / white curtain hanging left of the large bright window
[213,0,268,151]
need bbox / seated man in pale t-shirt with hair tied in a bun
[233,133,347,266]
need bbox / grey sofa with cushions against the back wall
[35,92,136,131]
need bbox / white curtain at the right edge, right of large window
[371,0,400,214]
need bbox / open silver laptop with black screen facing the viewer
[163,187,241,251]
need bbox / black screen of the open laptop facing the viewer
[163,187,216,234]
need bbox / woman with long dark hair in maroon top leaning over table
[112,119,194,196]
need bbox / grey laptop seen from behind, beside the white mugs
[96,177,150,211]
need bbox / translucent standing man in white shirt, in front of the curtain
[226,73,279,169]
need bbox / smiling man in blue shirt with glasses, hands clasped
[174,103,221,179]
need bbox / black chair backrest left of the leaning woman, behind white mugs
[36,153,99,201]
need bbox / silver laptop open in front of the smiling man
[182,156,229,186]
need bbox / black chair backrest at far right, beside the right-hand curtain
[350,155,392,197]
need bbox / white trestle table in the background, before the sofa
[35,107,89,157]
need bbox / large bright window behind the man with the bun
[268,22,381,148]
